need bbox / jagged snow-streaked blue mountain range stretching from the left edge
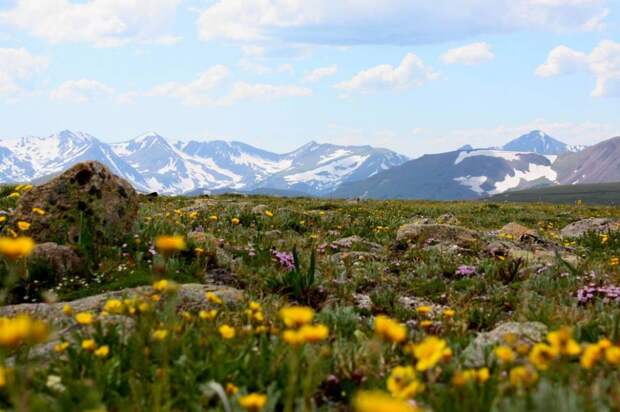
[0,131,408,195]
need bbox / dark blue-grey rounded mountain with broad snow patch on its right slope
[333,149,558,200]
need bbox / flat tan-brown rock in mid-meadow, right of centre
[396,223,480,249]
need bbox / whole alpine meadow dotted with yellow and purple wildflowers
[0,187,620,412]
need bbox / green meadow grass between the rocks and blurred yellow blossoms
[0,191,620,412]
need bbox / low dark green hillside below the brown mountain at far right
[487,182,620,206]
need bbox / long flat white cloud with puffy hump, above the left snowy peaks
[146,65,312,106]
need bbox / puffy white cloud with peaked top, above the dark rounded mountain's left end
[335,53,439,93]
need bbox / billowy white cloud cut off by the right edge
[535,40,620,97]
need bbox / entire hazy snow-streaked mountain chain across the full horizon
[0,130,620,199]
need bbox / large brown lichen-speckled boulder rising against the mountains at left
[15,162,138,244]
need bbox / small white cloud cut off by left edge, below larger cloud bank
[0,48,49,97]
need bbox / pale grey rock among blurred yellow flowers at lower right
[461,322,549,368]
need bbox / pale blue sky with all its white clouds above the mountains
[0,0,620,156]
